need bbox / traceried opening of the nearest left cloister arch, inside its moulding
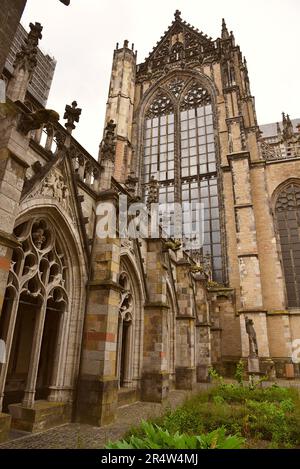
[0,217,70,412]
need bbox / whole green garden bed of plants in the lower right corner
[110,362,300,449]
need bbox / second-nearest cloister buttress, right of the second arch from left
[141,239,169,402]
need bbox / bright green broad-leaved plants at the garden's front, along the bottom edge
[106,421,244,449]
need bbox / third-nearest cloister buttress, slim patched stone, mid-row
[175,258,196,389]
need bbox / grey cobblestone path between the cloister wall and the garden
[0,385,207,449]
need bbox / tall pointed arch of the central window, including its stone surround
[134,69,227,283]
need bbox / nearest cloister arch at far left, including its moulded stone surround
[0,205,87,406]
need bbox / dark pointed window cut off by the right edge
[275,183,300,308]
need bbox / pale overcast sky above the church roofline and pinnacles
[22,0,300,157]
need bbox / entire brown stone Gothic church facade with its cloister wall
[0,11,300,438]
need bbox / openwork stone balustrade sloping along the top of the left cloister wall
[31,124,101,193]
